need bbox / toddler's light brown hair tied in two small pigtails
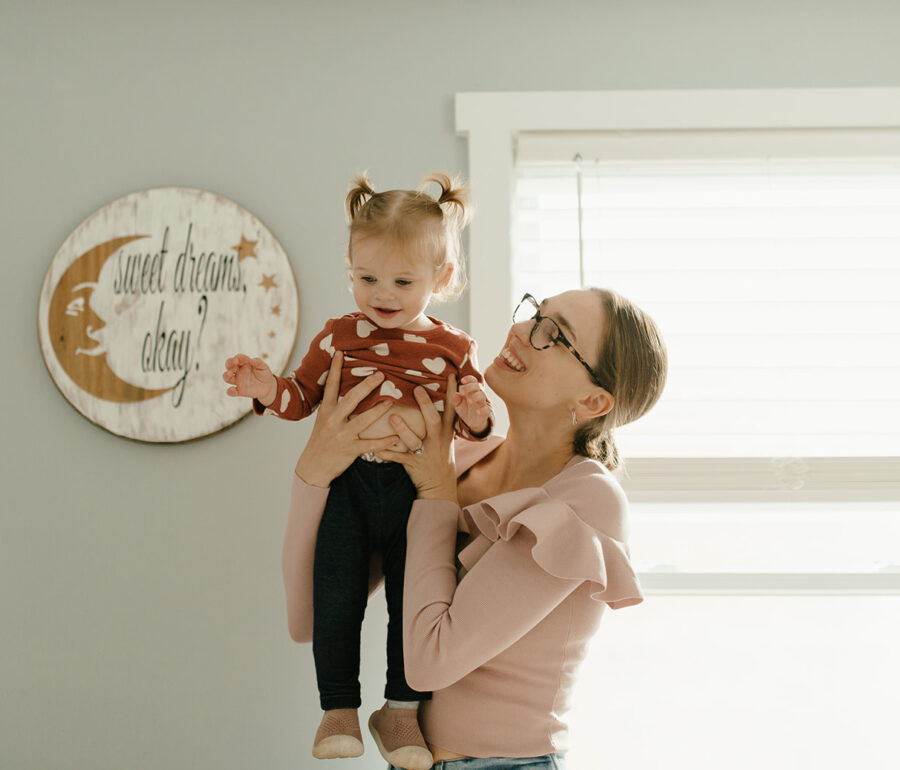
[346,171,471,301]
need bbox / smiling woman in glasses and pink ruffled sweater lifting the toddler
[283,289,667,770]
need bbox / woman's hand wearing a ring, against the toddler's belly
[378,374,457,502]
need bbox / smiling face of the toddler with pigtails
[350,237,440,331]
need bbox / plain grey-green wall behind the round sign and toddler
[0,0,900,770]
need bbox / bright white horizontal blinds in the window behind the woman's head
[512,158,900,457]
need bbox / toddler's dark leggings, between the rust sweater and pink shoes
[313,458,430,710]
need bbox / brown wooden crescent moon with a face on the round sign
[48,235,172,403]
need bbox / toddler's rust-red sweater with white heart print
[253,312,493,438]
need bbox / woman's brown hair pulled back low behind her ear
[575,288,668,471]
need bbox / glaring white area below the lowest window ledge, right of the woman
[568,596,900,770]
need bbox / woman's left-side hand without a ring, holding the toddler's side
[294,351,397,487]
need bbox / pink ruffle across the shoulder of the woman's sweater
[459,487,643,609]
